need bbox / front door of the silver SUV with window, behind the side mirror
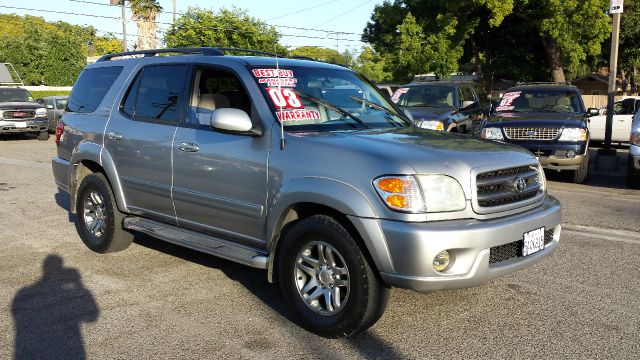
[173,65,269,247]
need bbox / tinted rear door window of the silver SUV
[122,65,186,123]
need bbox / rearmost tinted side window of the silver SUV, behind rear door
[66,66,122,113]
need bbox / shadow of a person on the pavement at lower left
[11,255,100,359]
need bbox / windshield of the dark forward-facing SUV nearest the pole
[495,89,584,113]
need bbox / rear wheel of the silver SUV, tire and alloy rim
[76,173,133,254]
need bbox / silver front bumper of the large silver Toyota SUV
[371,196,562,292]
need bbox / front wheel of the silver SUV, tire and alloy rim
[278,215,389,338]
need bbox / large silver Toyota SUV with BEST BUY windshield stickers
[53,48,561,337]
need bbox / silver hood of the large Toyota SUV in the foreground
[295,128,537,196]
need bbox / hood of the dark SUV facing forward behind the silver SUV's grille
[489,112,585,127]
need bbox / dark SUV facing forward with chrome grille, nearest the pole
[481,83,598,183]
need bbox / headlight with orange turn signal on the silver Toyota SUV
[373,175,466,213]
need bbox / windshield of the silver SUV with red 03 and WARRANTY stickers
[251,66,411,131]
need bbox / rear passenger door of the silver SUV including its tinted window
[105,64,187,223]
